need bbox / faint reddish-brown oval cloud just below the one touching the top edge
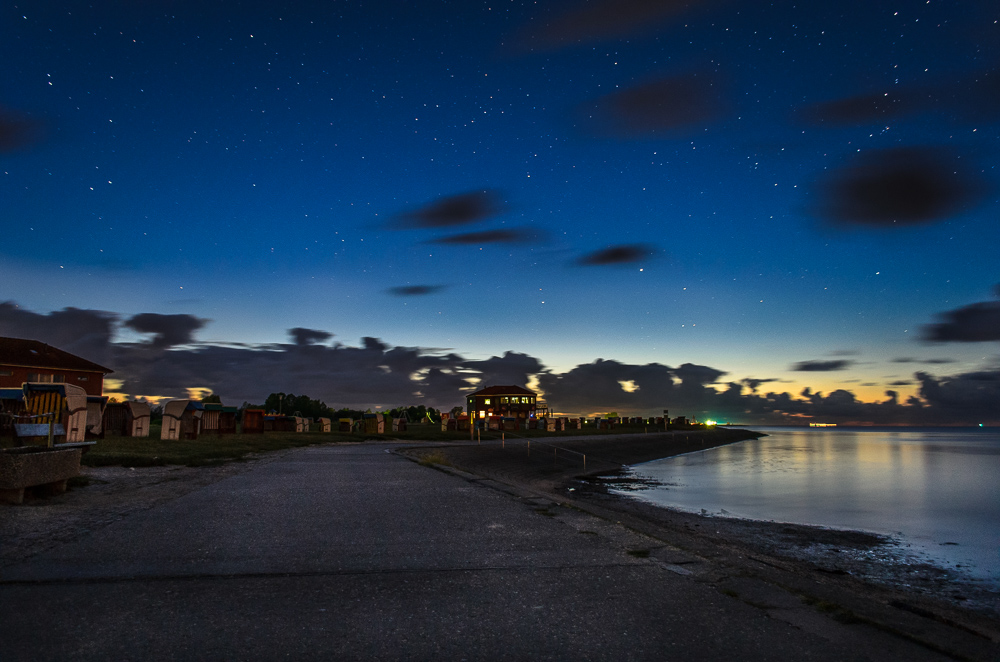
[579,73,724,138]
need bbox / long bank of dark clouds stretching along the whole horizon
[0,302,1000,425]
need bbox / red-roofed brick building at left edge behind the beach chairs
[0,338,114,395]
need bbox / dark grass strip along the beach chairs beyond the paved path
[83,424,704,467]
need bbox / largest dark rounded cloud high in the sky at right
[817,147,984,227]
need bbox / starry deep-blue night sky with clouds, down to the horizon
[0,0,1000,424]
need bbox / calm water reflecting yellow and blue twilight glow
[616,428,1000,583]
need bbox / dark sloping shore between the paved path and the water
[398,429,1000,642]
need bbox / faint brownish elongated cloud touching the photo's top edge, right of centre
[514,0,707,51]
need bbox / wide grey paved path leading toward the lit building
[0,445,937,661]
